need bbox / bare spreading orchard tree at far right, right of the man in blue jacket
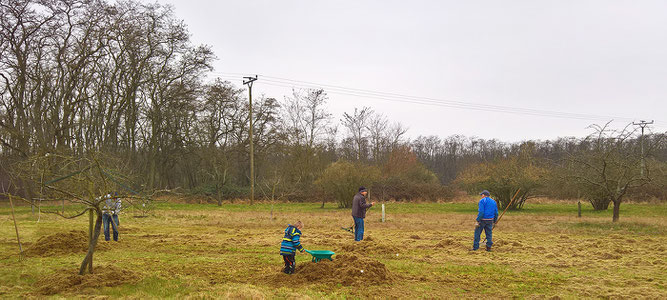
[566,122,657,222]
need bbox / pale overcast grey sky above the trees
[149,0,667,142]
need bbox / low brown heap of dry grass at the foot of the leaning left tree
[36,265,139,295]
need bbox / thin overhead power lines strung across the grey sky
[210,73,656,121]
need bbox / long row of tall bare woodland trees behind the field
[0,0,667,220]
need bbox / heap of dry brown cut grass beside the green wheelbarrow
[295,254,391,286]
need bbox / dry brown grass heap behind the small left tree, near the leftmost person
[25,230,110,256]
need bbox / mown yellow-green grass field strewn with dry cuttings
[0,200,667,299]
